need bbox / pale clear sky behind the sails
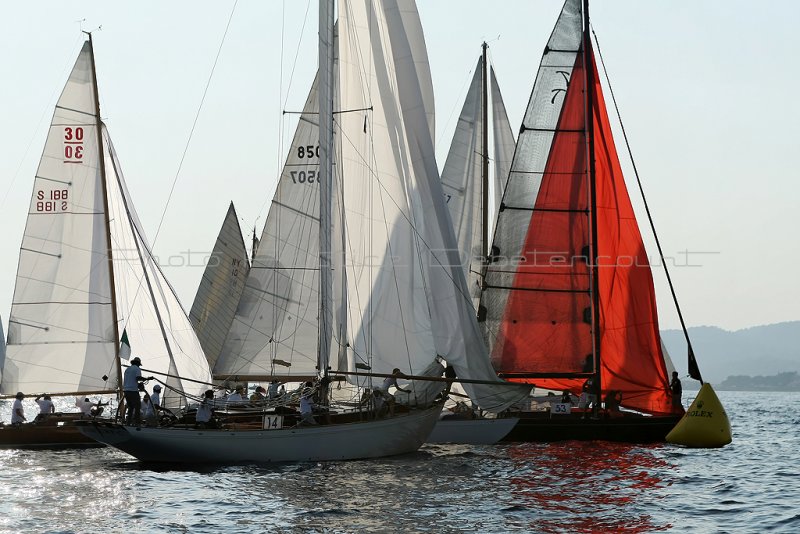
[0,0,800,336]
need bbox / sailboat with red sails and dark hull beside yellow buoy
[480,0,728,442]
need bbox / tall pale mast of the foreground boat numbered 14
[317,0,334,377]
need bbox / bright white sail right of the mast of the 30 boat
[103,128,211,408]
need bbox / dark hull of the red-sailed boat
[502,412,680,443]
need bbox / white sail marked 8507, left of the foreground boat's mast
[213,80,319,377]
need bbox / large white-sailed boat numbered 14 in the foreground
[76,0,520,463]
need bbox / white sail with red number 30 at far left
[0,42,117,395]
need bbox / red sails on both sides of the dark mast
[492,48,671,414]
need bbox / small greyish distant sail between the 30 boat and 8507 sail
[189,202,250,368]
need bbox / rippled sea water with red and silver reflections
[0,392,800,534]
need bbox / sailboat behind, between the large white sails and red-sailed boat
[428,43,518,444]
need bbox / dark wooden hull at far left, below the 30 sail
[0,416,105,449]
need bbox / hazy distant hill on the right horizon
[661,321,800,387]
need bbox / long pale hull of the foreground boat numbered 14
[80,406,441,463]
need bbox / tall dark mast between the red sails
[583,0,602,404]
